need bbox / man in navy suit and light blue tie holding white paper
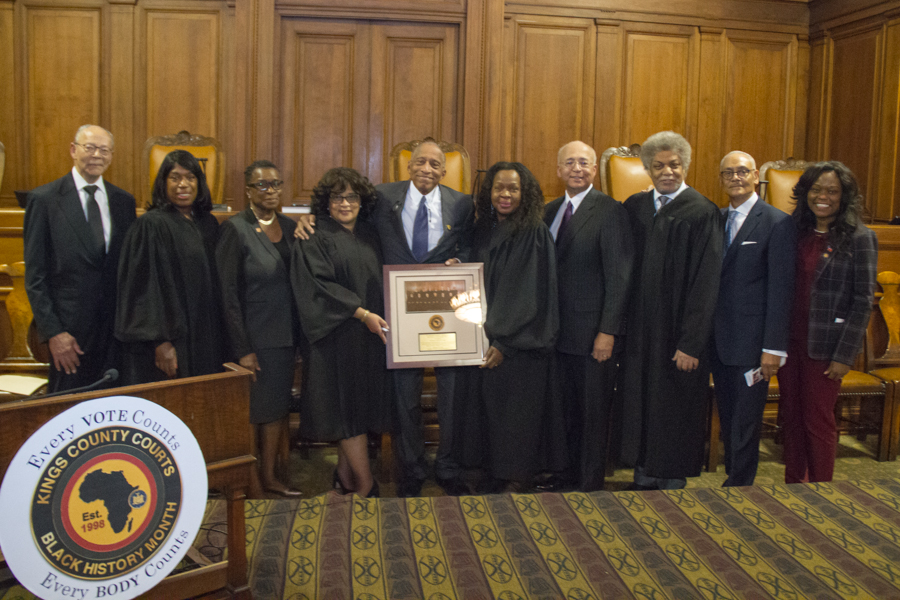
[710,152,795,486]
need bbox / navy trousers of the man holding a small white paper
[711,352,769,487]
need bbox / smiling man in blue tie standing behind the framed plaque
[374,141,474,497]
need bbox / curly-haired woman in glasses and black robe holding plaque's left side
[291,167,389,497]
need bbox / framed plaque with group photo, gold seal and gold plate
[384,263,488,369]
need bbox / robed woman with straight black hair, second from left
[116,150,222,385]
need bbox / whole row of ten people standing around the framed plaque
[25,126,877,497]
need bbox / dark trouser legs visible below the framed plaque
[393,367,460,480]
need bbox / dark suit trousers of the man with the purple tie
[556,352,616,492]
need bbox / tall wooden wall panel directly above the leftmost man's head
[19,4,104,189]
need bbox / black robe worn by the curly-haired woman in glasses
[291,217,390,441]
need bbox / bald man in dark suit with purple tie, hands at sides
[536,142,634,492]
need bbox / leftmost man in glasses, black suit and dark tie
[24,125,135,392]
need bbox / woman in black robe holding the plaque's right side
[460,162,565,493]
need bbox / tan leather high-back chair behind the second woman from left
[141,131,225,204]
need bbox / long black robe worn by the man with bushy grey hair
[618,188,723,478]
